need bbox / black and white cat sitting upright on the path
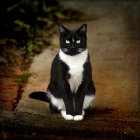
[30,24,95,121]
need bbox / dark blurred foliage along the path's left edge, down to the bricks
[0,0,80,102]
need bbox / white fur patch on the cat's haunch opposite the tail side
[83,95,95,109]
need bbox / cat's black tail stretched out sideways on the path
[29,91,50,103]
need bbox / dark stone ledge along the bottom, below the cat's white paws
[0,111,140,139]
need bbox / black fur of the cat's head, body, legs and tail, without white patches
[30,24,95,116]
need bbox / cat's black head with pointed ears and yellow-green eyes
[59,24,87,55]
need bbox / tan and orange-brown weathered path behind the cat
[13,1,139,138]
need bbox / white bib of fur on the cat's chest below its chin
[59,49,88,93]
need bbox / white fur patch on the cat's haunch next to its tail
[47,92,65,110]
